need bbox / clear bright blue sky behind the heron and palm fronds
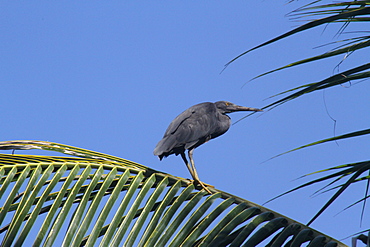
[0,0,370,244]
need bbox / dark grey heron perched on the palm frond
[153,101,262,194]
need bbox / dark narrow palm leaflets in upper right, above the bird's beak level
[225,1,370,116]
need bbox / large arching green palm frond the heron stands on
[0,141,345,246]
